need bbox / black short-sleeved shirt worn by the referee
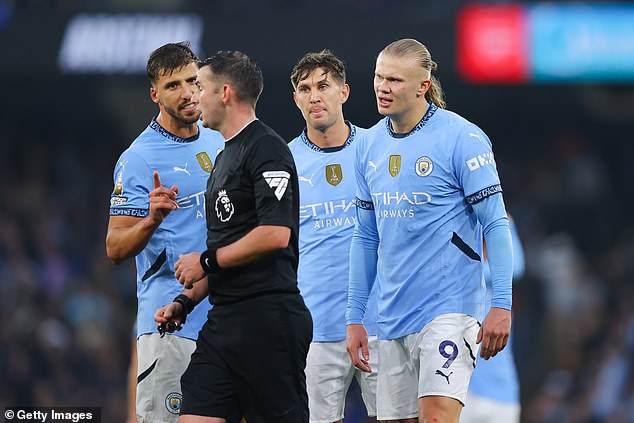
[205,120,299,305]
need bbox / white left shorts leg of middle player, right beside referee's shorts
[306,341,354,423]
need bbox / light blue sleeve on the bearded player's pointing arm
[110,150,154,217]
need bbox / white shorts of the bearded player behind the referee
[136,333,196,422]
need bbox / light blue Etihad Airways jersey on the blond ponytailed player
[356,104,501,339]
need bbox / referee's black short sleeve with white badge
[248,135,298,227]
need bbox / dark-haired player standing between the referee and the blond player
[289,50,377,423]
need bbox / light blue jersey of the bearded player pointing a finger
[110,120,224,339]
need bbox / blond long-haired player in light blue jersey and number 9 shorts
[346,39,513,423]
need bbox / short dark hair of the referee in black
[199,50,264,107]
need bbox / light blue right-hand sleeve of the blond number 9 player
[453,125,502,204]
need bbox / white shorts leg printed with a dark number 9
[411,314,479,404]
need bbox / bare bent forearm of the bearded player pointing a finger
[106,218,158,264]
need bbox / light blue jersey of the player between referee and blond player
[289,123,376,342]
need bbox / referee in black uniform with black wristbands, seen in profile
[174,51,312,423]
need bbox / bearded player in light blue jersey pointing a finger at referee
[106,42,224,422]
